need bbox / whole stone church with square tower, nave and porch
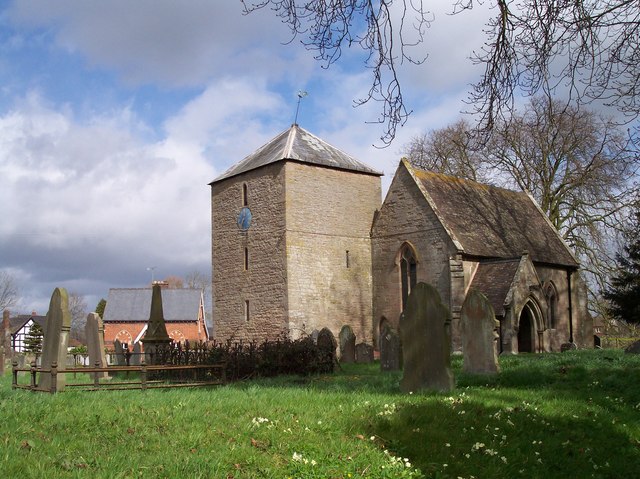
[210,125,593,353]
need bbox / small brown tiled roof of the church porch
[470,259,520,316]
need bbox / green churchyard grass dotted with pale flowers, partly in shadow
[0,350,640,479]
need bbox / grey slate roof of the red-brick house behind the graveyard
[103,288,202,323]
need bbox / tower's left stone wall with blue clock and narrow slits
[211,162,288,341]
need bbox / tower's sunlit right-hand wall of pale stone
[285,162,381,343]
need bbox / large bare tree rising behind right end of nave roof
[410,98,640,304]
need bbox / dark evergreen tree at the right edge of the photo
[603,211,640,324]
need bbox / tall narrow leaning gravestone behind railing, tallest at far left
[38,288,71,392]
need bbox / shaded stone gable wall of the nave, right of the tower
[371,163,464,344]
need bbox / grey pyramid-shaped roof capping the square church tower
[210,124,382,184]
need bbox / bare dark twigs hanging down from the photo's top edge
[242,0,640,144]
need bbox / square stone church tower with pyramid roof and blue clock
[210,124,382,343]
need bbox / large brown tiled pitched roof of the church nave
[410,160,578,268]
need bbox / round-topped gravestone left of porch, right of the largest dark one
[460,289,500,374]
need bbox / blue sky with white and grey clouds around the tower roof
[0,0,486,314]
